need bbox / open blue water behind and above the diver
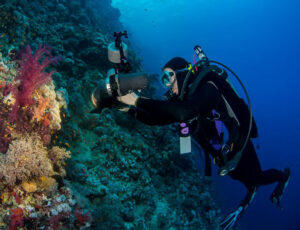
[113,0,300,230]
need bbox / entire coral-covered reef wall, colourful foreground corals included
[0,0,220,229]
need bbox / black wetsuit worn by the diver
[130,69,284,207]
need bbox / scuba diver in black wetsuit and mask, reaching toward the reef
[113,53,290,230]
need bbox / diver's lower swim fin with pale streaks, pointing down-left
[221,186,257,230]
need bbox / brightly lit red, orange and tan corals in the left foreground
[0,46,76,229]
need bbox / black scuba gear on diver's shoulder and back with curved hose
[179,46,258,158]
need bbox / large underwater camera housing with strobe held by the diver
[91,31,148,113]
